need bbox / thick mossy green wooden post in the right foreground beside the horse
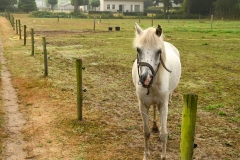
[180,94,198,160]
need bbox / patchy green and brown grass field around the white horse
[1,15,240,159]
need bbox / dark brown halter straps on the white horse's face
[137,54,172,95]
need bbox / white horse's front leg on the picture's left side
[139,103,150,160]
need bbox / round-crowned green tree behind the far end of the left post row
[18,0,37,13]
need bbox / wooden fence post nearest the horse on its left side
[76,59,83,120]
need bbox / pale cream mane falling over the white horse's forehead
[133,27,164,49]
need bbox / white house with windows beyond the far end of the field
[100,0,144,12]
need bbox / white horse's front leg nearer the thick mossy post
[160,99,168,160]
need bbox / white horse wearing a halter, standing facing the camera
[132,23,181,160]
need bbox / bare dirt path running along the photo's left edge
[0,35,27,160]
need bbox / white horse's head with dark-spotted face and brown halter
[134,23,164,88]
